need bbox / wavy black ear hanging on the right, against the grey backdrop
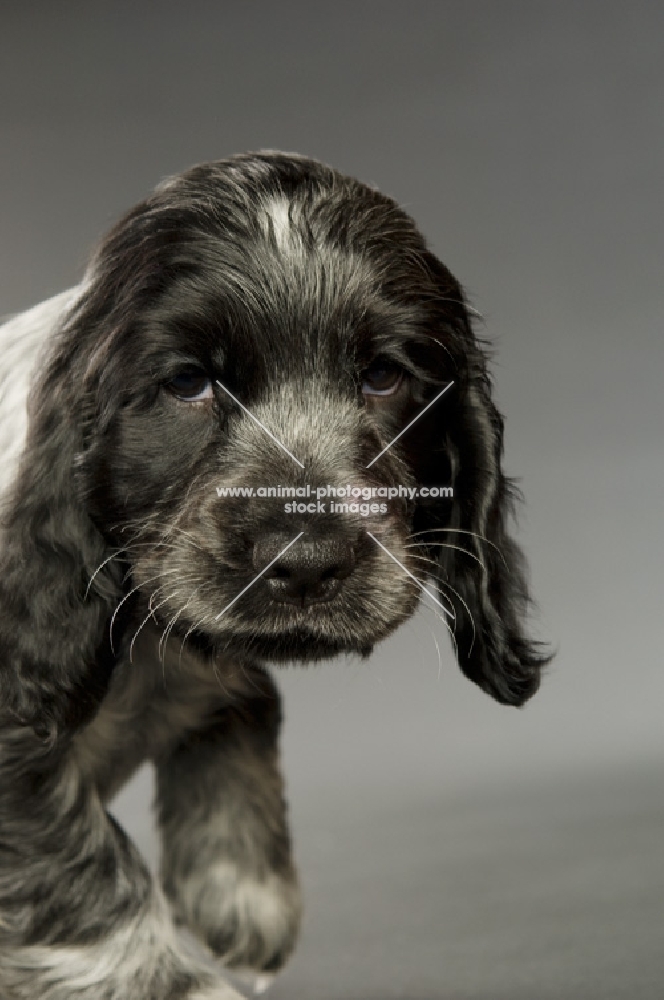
[419,255,553,705]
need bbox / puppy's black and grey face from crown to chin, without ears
[80,160,462,660]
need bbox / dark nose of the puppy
[253,533,355,608]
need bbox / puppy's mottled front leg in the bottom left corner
[0,728,241,1000]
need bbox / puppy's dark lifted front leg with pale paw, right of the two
[155,668,301,972]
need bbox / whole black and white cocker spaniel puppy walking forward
[0,152,547,1000]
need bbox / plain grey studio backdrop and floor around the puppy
[0,0,664,1000]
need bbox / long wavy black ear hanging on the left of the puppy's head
[0,180,233,741]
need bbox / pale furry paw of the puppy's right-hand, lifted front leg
[169,861,302,976]
